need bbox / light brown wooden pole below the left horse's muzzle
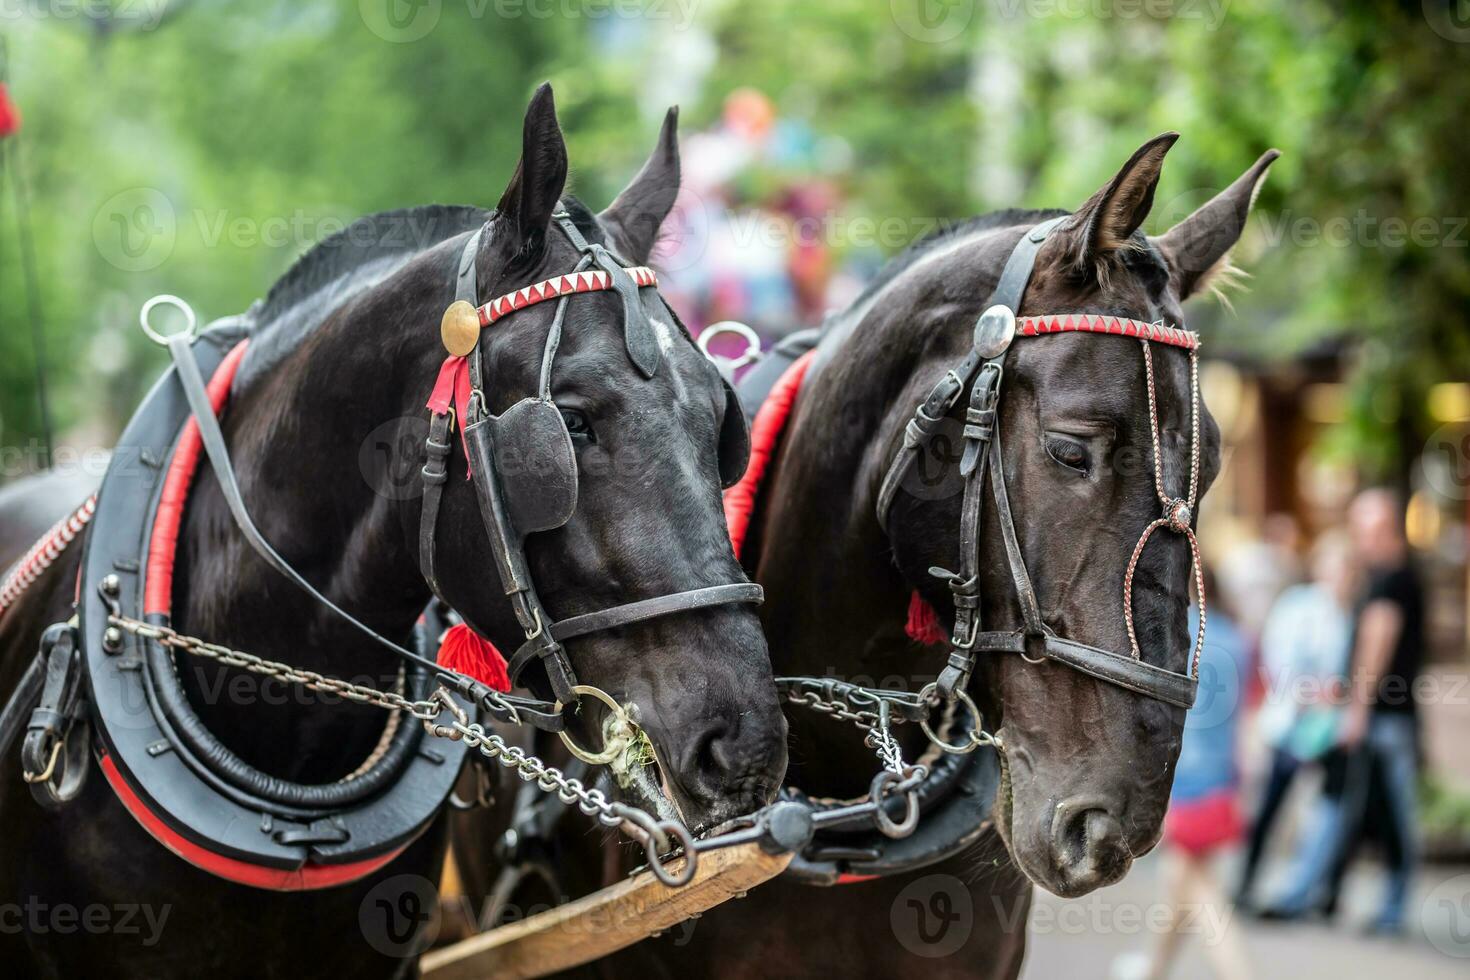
[419,843,792,980]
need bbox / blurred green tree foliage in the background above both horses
[0,0,1470,472]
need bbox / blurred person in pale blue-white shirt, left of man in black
[1235,532,1357,908]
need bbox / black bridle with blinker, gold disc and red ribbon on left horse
[419,210,764,702]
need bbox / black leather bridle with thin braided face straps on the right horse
[878,215,1205,708]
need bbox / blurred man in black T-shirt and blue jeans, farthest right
[1269,489,1424,933]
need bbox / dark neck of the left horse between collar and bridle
[173,274,442,774]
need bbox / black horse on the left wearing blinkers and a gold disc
[0,87,785,976]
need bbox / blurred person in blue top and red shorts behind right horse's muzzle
[1113,566,1254,980]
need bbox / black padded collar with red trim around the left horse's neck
[75,327,466,890]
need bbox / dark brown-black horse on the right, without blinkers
[479,134,1276,977]
